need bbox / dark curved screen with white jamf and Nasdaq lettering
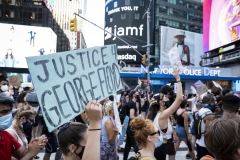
[104,0,154,64]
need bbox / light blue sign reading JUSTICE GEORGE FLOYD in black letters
[26,45,122,132]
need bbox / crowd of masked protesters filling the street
[0,69,240,160]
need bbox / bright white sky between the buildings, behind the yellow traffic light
[84,0,105,47]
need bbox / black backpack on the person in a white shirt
[193,108,213,139]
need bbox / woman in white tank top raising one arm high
[148,69,183,160]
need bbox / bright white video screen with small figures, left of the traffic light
[0,23,57,68]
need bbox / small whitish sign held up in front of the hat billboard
[168,47,183,73]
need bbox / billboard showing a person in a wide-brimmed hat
[160,26,203,67]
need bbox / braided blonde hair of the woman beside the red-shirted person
[14,105,37,147]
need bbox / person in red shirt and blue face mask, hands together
[0,93,48,160]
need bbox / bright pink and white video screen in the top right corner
[203,0,240,52]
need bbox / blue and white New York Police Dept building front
[121,65,240,93]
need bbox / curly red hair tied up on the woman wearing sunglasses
[130,118,155,147]
